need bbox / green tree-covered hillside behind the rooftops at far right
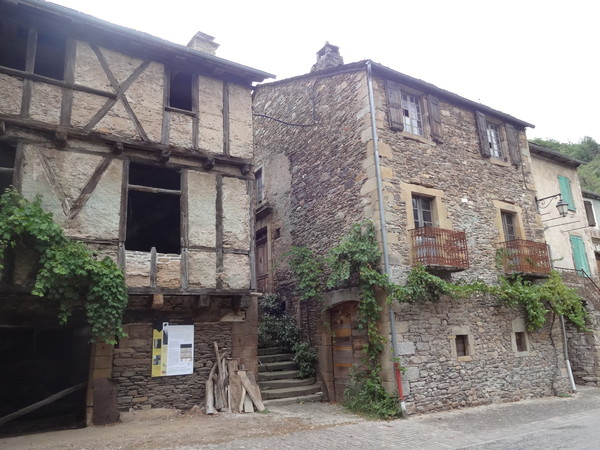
[531,136,600,193]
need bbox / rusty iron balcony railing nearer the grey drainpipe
[409,226,469,272]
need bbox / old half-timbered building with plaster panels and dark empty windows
[0,0,272,430]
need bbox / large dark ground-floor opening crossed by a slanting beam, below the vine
[0,327,90,436]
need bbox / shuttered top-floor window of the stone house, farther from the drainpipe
[475,111,521,166]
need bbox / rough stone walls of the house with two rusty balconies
[254,64,567,411]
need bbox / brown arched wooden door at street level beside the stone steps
[331,302,366,402]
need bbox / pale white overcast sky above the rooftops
[55,0,600,142]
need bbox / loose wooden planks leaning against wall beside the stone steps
[206,342,265,414]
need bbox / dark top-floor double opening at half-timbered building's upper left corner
[0,22,66,80]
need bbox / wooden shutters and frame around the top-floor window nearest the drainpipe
[385,80,442,143]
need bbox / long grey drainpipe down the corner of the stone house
[366,61,406,416]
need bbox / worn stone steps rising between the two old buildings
[258,341,322,407]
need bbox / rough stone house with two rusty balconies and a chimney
[253,43,568,412]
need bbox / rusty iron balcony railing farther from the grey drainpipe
[499,239,551,277]
